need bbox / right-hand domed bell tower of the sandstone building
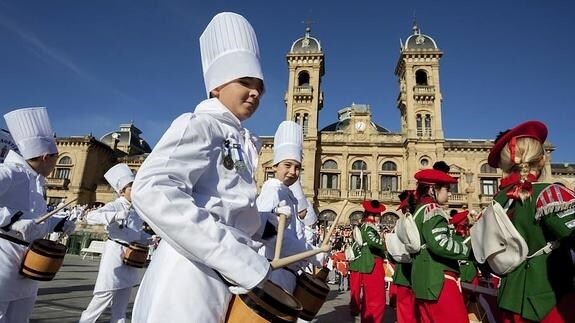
[395,23,444,140]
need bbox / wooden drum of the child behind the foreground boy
[293,272,329,321]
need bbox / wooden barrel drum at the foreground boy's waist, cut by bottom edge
[226,281,302,323]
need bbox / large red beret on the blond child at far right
[487,121,547,168]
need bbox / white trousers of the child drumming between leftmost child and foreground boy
[79,287,132,323]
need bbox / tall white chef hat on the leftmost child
[4,107,58,160]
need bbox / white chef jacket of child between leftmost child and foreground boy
[87,197,148,294]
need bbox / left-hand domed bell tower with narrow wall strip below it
[284,26,324,195]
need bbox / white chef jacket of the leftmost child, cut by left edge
[0,151,59,302]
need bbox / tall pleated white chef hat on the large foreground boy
[200,12,264,97]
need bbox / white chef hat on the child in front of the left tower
[274,120,303,165]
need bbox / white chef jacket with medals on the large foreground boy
[132,99,270,323]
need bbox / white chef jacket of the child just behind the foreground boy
[257,178,323,294]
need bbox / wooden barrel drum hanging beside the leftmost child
[20,239,66,281]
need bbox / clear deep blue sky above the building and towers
[0,0,575,162]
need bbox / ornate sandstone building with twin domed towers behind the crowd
[48,26,575,227]
